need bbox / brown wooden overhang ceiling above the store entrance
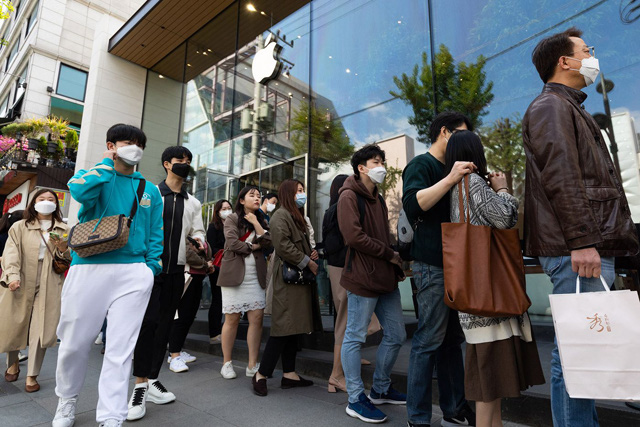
[109,0,309,82]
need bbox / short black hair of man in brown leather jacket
[531,27,582,83]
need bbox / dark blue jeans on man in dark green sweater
[407,262,467,424]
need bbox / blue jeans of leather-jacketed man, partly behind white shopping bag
[539,256,615,427]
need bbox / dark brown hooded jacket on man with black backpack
[338,175,398,297]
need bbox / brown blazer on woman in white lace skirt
[217,213,271,289]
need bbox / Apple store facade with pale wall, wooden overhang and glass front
[35,0,640,315]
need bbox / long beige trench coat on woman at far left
[0,220,70,353]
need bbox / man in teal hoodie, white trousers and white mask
[52,124,163,427]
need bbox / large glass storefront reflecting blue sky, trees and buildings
[140,0,640,316]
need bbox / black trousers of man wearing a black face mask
[133,271,184,379]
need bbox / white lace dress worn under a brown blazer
[220,231,266,314]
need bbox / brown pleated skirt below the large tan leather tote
[464,337,545,402]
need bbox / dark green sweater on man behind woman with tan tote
[402,153,449,267]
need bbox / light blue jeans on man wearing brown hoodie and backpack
[342,289,407,403]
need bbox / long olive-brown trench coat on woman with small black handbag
[269,208,322,337]
